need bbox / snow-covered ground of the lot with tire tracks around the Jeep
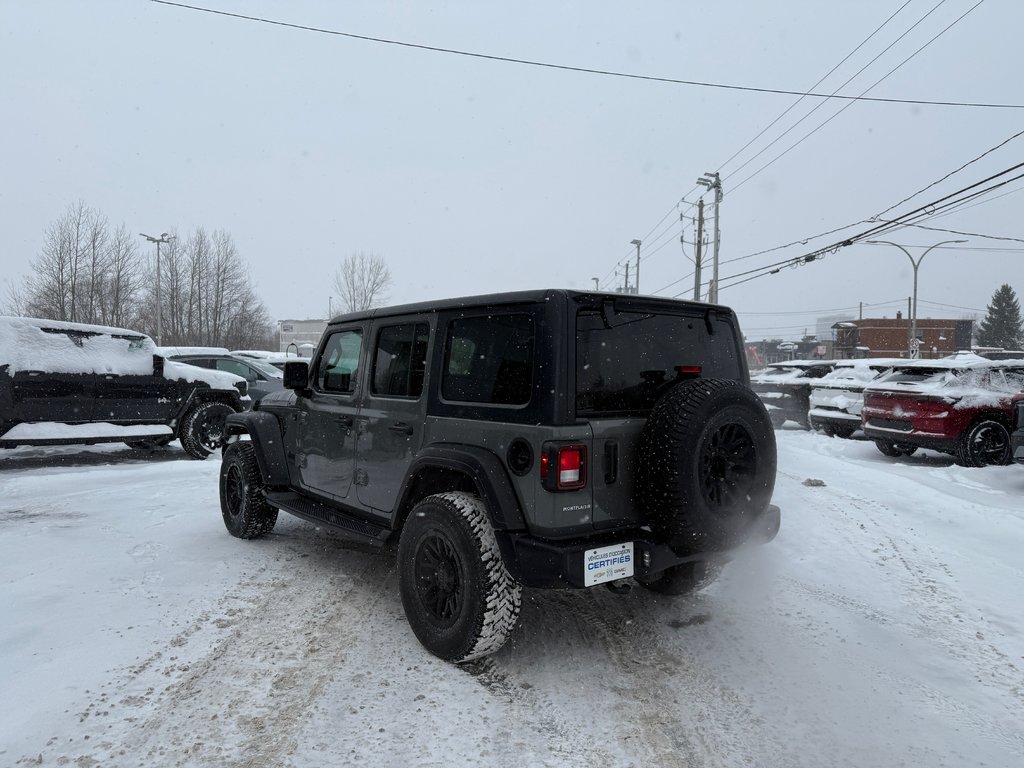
[0,431,1024,768]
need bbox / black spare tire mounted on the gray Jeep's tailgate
[635,379,776,554]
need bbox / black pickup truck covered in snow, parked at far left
[0,317,249,459]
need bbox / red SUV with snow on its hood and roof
[862,354,1024,467]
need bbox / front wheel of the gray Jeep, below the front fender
[220,441,278,539]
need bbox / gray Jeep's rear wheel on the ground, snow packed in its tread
[398,493,522,663]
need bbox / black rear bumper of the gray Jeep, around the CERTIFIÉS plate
[495,504,781,589]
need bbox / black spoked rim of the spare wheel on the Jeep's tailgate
[699,424,758,513]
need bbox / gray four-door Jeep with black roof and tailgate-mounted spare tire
[220,290,779,662]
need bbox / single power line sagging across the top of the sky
[150,0,1024,110]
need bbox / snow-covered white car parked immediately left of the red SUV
[807,357,900,437]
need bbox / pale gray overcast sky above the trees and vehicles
[0,0,1024,338]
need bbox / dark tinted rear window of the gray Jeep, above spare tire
[575,309,742,415]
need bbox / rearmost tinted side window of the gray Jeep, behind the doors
[441,314,535,406]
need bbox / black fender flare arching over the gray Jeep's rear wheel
[395,442,526,531]
